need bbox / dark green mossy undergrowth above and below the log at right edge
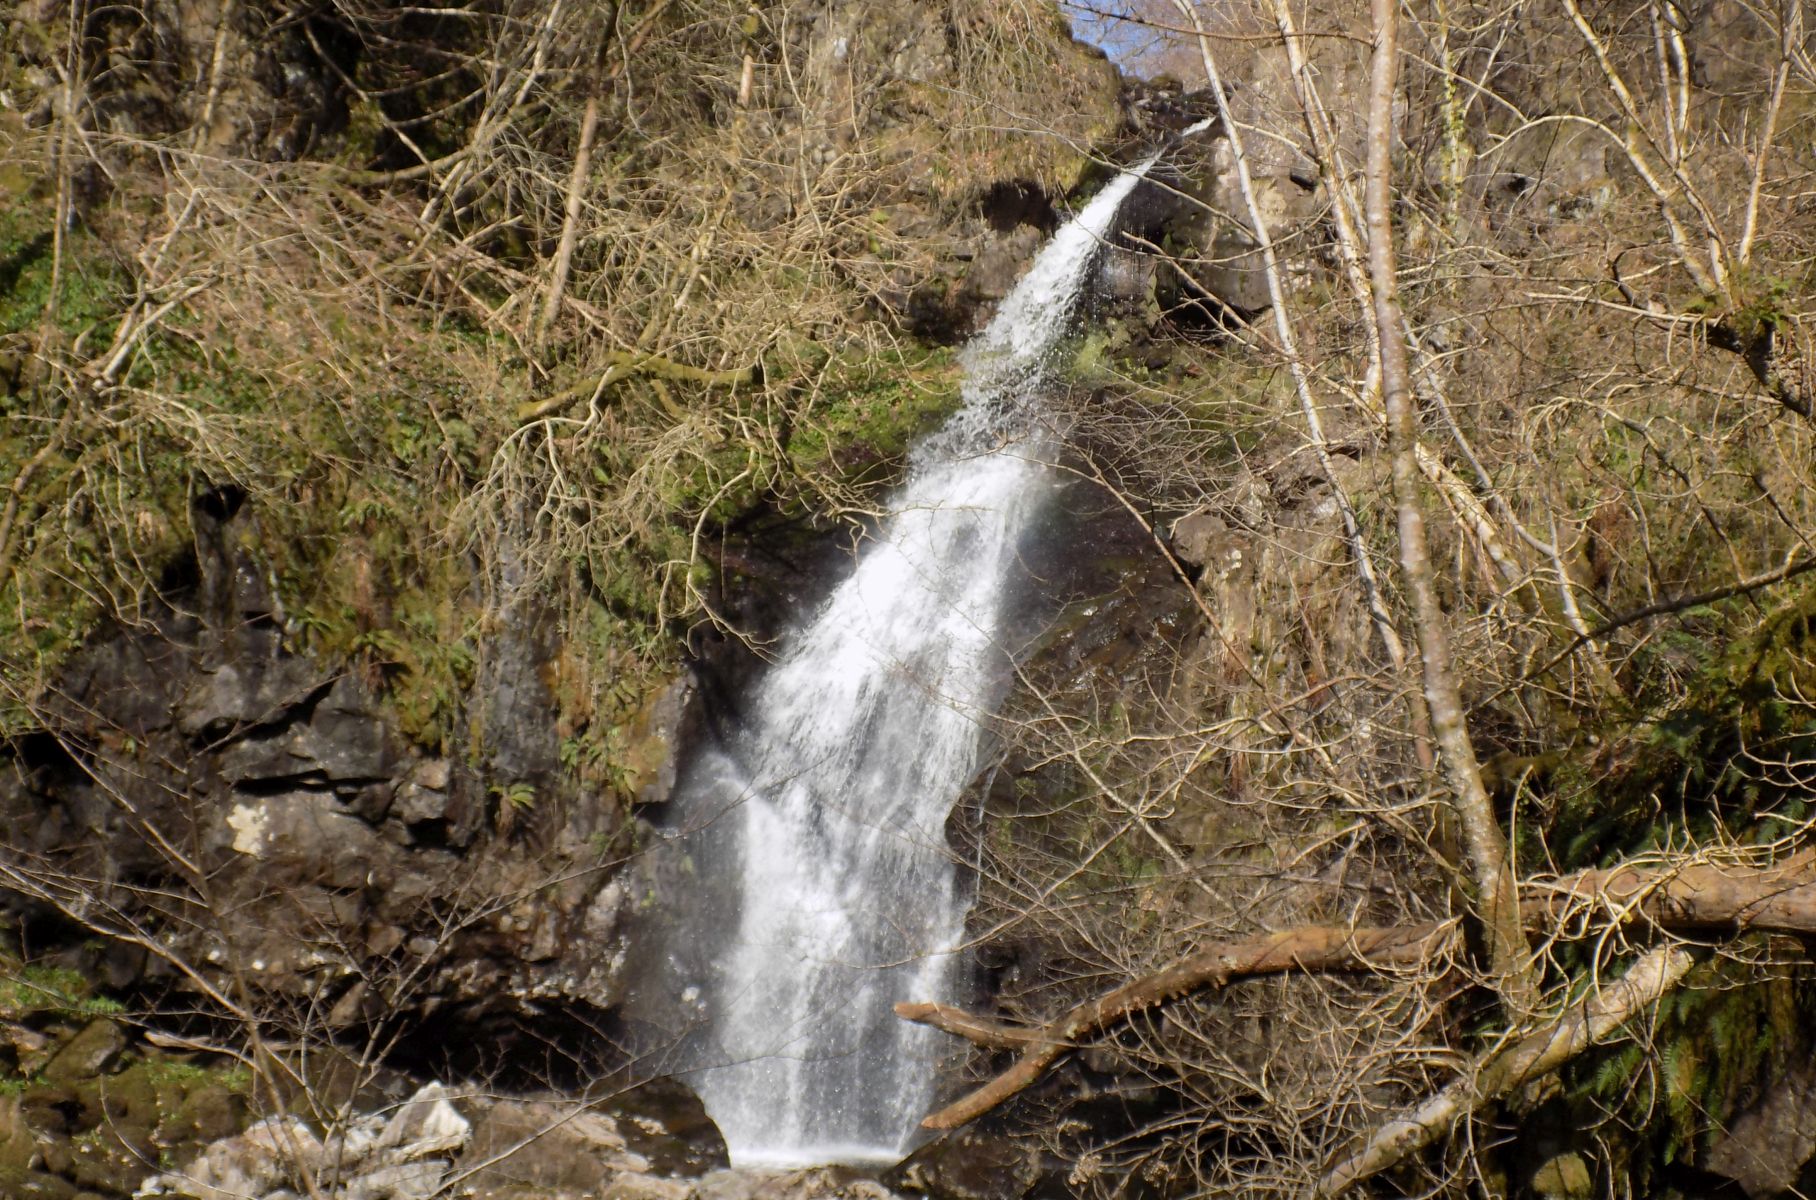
[1520,586,1816,1185]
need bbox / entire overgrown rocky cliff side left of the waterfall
[0,0,1176,1196]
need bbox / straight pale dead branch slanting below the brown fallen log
[1315,946,1691,1196]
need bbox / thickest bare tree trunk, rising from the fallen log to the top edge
[1364,0,1538,1022]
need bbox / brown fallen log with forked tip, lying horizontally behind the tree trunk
[895,851,1816,1129]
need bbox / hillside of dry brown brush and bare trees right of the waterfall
[943,2,1816,1195]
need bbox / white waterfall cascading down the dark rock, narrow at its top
[676,147,1153,1166]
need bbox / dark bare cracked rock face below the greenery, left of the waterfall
[0,486,627,1037]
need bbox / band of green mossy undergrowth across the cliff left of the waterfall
[0,152,959,788]
